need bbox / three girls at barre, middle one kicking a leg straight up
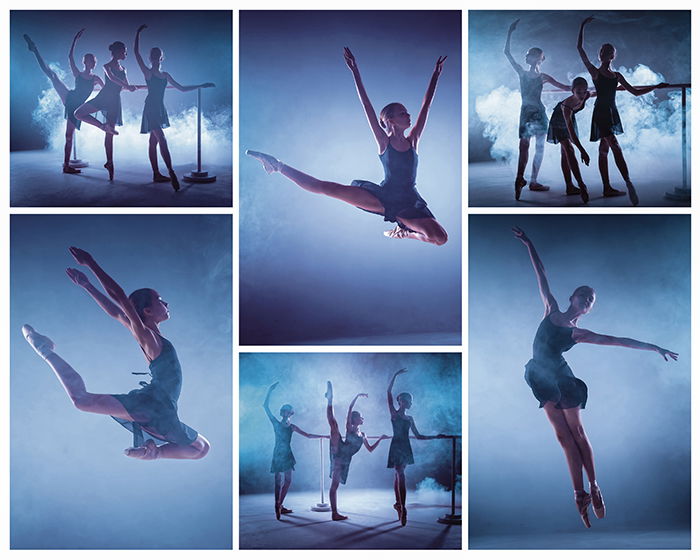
[263,369,449,525]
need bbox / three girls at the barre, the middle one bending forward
[504,17,668,206]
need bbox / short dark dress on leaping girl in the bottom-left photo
[112,335,198,447]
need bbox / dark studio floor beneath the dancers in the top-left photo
[10,150,232,207]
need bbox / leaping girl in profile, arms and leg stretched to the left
[22,247,210,460]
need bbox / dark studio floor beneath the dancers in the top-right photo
[469,161,690,208]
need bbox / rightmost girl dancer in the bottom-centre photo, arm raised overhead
[386,368,447,526]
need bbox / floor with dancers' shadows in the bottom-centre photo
[239,487,462,549]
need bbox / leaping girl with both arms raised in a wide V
[246,47,447,245]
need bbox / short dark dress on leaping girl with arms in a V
[351,143,435,229]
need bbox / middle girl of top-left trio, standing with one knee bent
[75,41,139,181]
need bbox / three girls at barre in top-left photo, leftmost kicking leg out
[24,25,214,191]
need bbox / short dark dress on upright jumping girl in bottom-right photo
[525,315,588,409]
